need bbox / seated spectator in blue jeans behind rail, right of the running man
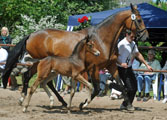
[137,50,161,102]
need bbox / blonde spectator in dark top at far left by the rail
[0,27,12,52]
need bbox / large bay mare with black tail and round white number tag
[2,4,149,108]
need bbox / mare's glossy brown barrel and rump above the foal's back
[26,29,85,58]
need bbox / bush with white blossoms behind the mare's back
[12,15,64,44]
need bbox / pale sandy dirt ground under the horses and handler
[0,88,167,120]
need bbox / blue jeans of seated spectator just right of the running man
[136,74,156,93]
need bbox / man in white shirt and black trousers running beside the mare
[117,30,152,110]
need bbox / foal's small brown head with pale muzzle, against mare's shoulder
[86,36,100,56]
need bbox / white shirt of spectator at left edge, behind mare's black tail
[0,48,8,69]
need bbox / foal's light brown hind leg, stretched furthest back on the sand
[23,78,40,112]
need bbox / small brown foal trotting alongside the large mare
[23,36,100,112]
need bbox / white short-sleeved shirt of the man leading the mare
[117,37,139,67]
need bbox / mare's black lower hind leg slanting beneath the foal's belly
[47,81,67,107]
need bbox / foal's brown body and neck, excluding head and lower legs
[38,38,87,78]
